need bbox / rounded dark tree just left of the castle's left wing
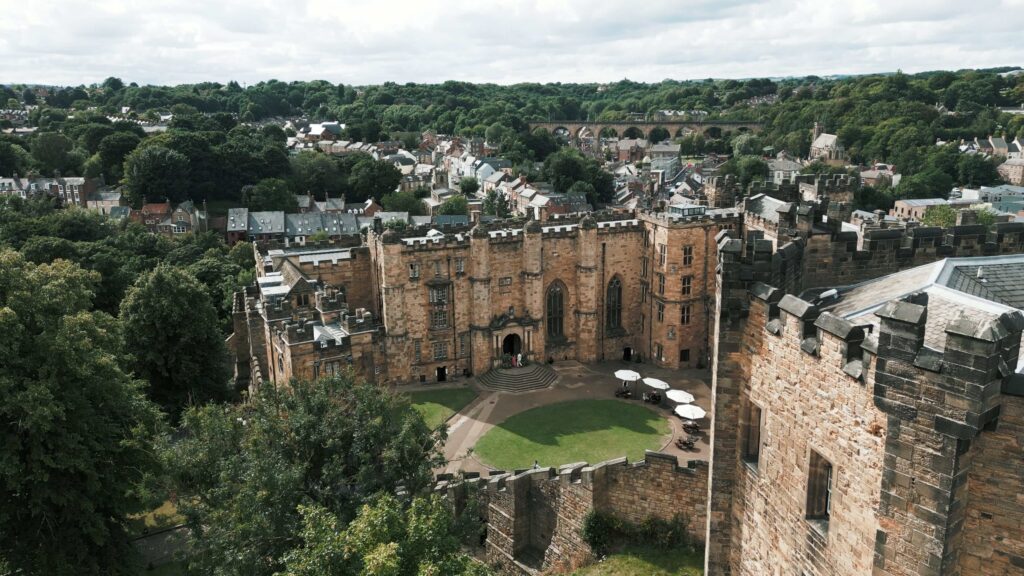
[121,264,230,415]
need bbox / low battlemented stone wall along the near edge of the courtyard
[436,451,708,575]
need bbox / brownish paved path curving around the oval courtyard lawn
[423,361,711,476]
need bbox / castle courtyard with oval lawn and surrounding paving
[400,361,711,476]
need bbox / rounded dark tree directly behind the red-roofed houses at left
[124,146,188,206]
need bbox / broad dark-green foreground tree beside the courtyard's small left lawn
[169,374,443,576]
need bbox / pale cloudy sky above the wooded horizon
[0,0,1024,84]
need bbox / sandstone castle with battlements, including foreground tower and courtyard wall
[231,172,1024,576]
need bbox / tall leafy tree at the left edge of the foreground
[0,250,160,576]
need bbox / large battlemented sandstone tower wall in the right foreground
[706,226,1024,576]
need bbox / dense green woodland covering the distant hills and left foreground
[0,71,1024,576]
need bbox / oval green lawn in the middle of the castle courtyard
[474,400,670,470]
